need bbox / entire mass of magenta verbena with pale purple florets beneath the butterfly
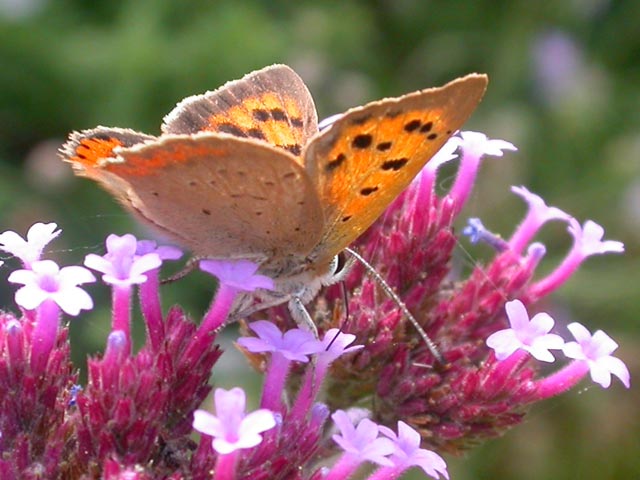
[0,127,630,480]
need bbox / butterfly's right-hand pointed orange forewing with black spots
[304,74,487,263]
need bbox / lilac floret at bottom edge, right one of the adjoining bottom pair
[379,420,449,479]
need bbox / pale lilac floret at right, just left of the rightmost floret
[487,300,564,362]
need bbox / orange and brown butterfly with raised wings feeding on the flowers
[61,65,487,330]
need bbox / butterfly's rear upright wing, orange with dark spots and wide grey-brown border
[162,65,318,156]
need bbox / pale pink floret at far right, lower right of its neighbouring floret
[562,322,630,388]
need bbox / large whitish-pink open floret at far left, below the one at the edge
[9,260,96,316]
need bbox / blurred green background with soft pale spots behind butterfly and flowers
[0,0,640,480]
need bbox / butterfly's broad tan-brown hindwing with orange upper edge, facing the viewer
[62,133,323,258]
